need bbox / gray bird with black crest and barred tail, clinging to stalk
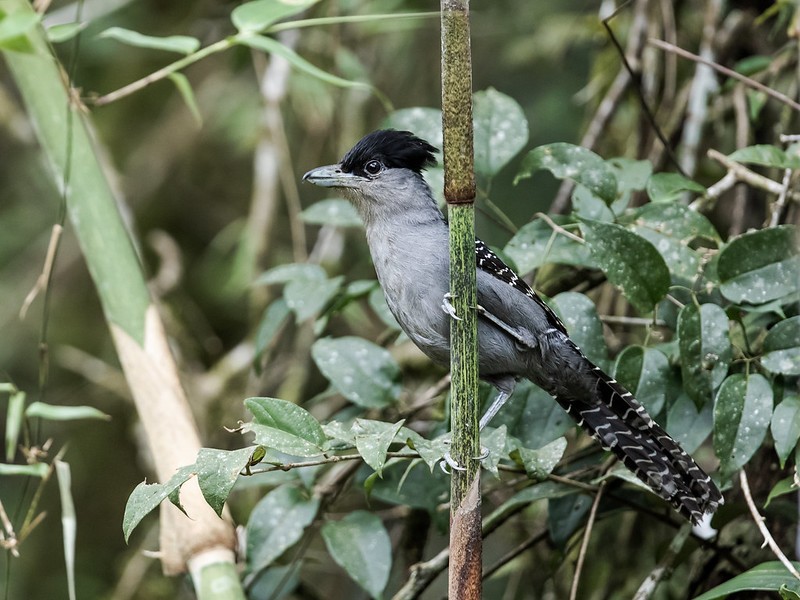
[303,130,723,523]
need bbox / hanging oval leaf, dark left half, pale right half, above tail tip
[714,373,772,478]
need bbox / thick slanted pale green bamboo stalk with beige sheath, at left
[0,0,244,599]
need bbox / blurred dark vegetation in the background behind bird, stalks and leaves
[0,0,798,599]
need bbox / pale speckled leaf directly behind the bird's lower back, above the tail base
[549,292,608,369]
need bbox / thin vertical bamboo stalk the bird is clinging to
[441,0,482,600]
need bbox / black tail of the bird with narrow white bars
[556,346,724,524]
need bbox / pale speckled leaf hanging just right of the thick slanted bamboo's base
[247,485,319,573]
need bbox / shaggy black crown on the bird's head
[341,129,438,173]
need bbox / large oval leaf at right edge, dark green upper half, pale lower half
[717,225,800,304]
